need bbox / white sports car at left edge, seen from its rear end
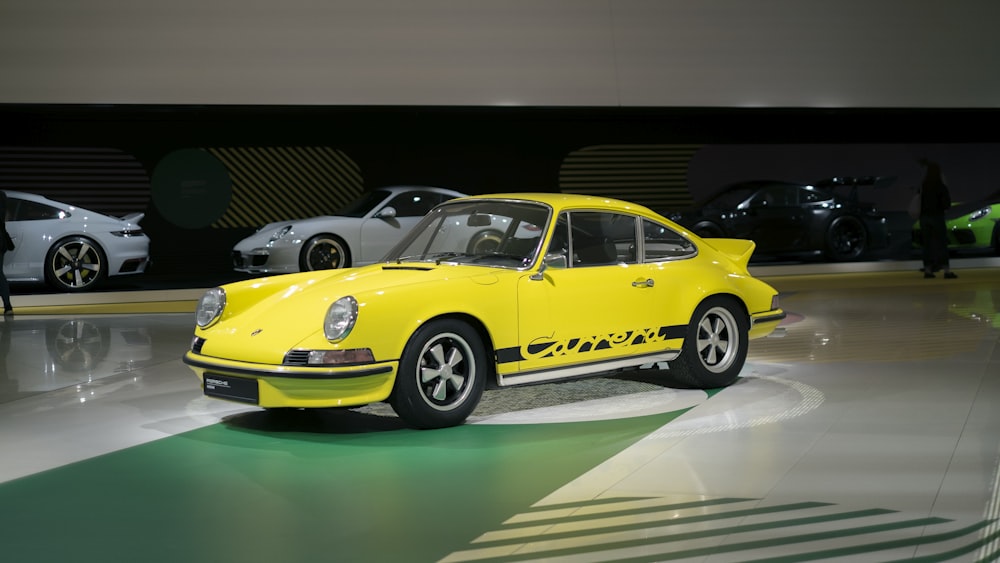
[3,191,149,292]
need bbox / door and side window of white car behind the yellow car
[355,190,451,265]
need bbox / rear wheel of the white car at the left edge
[45,236,108,293]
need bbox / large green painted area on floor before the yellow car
[0,411,683,563]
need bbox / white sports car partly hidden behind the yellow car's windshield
[233,186,465,274]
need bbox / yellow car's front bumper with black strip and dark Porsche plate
[183,351,398,408]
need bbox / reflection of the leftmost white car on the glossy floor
[0,316,153,403]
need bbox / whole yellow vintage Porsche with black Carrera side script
[184,194,785,428]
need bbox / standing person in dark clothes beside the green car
[919,158,958,279]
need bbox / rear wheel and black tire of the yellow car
[666,297,750,389]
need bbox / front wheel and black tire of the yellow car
[389,319,489,429]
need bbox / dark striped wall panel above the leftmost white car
[0,147,150,216]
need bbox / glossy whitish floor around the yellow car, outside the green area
[0,259,1000,563]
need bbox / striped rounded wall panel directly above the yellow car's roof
[559,145,701,211]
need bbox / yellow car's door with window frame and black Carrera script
[501,211,657,381]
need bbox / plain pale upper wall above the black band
[0,0,1000,108]
